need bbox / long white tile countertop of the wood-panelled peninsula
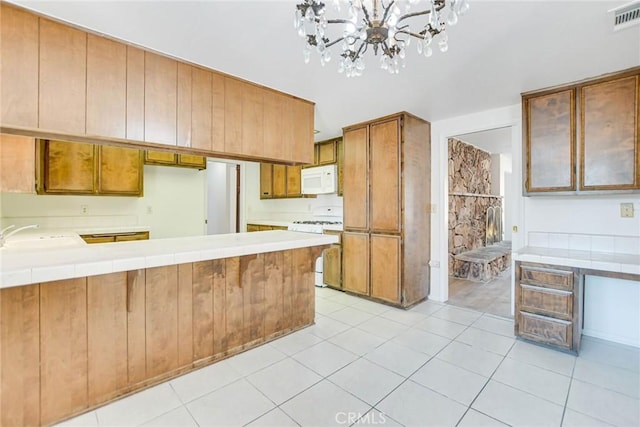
[0,230,338,289]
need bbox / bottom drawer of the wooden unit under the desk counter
[517,311,573,350]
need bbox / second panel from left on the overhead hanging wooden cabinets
[38,18,87,135]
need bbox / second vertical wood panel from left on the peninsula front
[40,277,88,424]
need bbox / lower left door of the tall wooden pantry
[342,232,369,295]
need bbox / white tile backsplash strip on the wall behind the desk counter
[527,231,640,255]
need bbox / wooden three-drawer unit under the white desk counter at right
[514,261,582,353]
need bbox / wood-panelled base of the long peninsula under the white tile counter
[0,246,325,426]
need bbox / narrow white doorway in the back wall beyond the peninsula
[206,160,240,234]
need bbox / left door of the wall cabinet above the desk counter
[524,89,576,192]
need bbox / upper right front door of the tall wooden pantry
[369,119,400,232]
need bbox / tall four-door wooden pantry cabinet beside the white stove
[342,112,431,307]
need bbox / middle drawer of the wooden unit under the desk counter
[519,283,573,320]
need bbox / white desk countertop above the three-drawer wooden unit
[513,246,640,274]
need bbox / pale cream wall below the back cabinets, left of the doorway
[0,165,206,238]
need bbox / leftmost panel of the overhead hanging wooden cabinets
[0,3,39,128]
